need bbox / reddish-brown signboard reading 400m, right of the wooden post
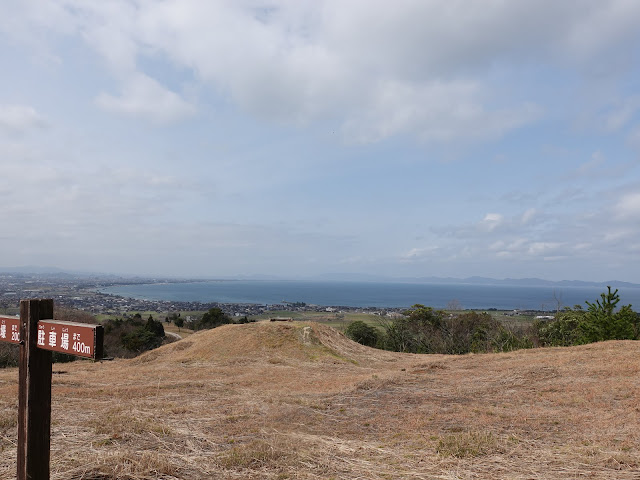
[37,320,104,359]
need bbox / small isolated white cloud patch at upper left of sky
[96,74,196,124]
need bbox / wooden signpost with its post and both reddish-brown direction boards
[0,299,104,480]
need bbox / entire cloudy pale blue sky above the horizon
[0,0,640,283]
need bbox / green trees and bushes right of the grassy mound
[345,287,640,354]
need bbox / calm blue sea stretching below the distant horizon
[96,280,640,311]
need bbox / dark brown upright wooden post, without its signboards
[18,299,53,480]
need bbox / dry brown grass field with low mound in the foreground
[0,323,640,480]
